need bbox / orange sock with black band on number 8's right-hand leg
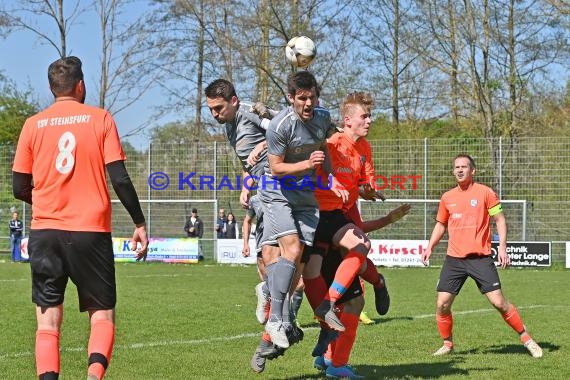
[87,320,115,379]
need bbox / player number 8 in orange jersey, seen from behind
[12,57,148,380]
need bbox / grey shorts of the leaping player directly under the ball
[258,186,319,246]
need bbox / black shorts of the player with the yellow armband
[437,255,501,294]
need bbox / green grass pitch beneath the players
[0,261,570,380]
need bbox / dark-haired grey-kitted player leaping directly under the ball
[258,71,348,348]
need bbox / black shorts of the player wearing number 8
[28,230,117,311]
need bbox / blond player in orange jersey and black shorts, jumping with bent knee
[303,92,408,378]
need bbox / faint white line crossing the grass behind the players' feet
[0,305,569,360]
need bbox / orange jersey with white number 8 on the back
[12,100,126,232]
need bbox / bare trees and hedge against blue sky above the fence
[0,0,570,147]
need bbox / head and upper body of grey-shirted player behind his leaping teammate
[204,79,277,207]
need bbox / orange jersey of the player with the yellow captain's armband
[436,183,500,258]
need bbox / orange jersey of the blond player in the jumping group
[315,133,374,211]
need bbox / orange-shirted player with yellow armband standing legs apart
[422,154,542,358]
